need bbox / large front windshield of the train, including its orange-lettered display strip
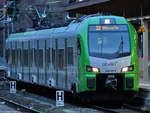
[88,25,131,59]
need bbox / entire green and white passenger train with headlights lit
[6,15,138,97]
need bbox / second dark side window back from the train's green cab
[58,49,64,69]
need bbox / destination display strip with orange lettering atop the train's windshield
[89,25,128,31]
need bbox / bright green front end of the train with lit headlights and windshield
[78,16,138,94]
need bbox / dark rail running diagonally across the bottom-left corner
[0,97,41,113]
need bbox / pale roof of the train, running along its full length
[8,15,128,40]
